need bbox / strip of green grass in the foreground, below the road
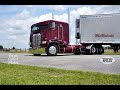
[0,63,120,85]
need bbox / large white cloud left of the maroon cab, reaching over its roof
[0,9,52,48]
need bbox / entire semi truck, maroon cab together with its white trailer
[30,14,120,56]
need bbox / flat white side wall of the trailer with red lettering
[80,14,120,44]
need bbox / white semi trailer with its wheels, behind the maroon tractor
[75,13,120,54]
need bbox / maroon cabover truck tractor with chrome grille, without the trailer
[30,20,84,56]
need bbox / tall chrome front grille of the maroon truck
[33,33,41,49]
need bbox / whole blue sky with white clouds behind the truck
[0,5,120,49]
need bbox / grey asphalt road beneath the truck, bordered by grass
[0,53,120,74]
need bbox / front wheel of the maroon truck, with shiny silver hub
[47,44,58,56]
